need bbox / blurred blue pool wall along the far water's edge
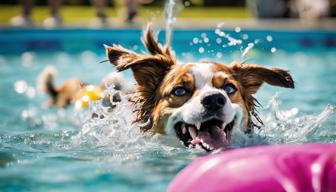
[0,28,336,54]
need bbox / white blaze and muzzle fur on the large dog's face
[165,63,243,140]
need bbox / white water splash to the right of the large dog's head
[250,95,336,144]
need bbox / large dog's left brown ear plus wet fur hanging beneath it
[105,25,176,127]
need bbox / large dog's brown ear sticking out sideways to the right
[231,63,294,94]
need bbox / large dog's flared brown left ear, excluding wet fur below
[105,25,175,86]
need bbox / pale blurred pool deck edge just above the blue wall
[0,18,336,31]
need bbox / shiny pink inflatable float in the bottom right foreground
[168,144,336,192]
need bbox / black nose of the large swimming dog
[201,93,226,111]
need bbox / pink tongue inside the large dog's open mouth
[194,125,229,149]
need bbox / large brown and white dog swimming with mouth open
[105,26,294,151]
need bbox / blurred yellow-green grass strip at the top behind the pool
[0,5,250,25]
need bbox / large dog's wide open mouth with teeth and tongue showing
[175,118,235,151]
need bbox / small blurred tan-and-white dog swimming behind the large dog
[37,66,131,109]
